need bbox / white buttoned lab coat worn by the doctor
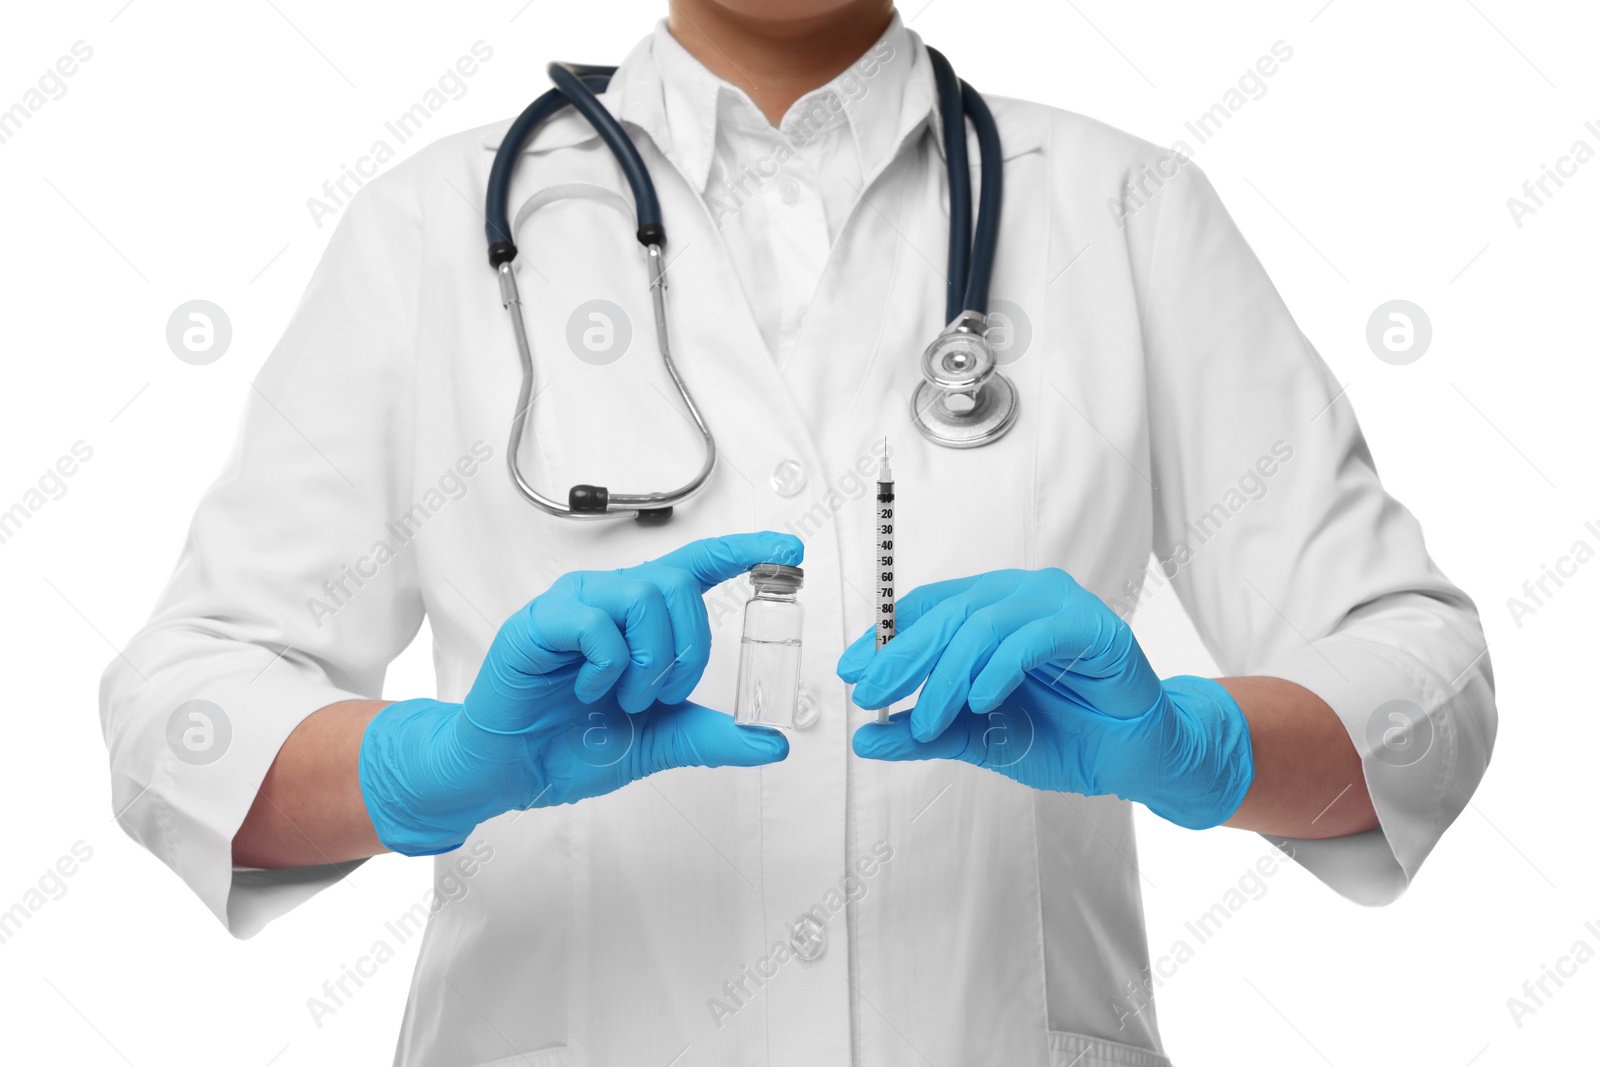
[102,24,1494,1067]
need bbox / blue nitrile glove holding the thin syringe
[838,569,1254,830]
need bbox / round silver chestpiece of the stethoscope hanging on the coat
[910,312,1018,448]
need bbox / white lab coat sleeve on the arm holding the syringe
[1130,163,1496,905]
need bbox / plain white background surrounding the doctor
[0,0,1600,1067]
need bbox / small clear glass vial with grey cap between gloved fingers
[733,563,805,729]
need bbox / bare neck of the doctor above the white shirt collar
[667,0,894,126]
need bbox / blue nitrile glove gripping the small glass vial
[360,533,805,856]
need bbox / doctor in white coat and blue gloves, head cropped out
[102,0,1494,1067]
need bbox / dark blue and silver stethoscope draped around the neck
[485,48,1018,523]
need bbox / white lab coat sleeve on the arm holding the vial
[101,179,422,937]
